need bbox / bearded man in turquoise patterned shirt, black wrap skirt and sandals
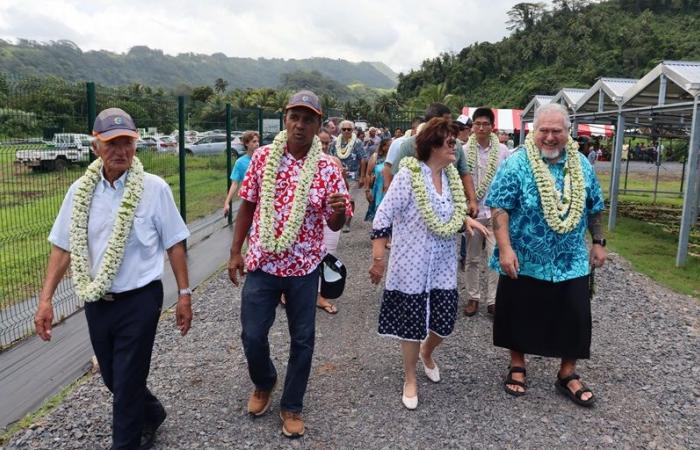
[486,104,607,406]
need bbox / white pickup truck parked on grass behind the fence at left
[15,133,92,171]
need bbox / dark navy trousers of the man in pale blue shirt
[85,281,164,450]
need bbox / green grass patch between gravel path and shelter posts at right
[606,217,700,299]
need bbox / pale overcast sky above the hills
[0,0,548,72]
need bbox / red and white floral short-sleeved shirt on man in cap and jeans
[239,146,352,277]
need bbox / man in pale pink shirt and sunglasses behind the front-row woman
[464,108,508,316]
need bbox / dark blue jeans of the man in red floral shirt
[241,268,319,412]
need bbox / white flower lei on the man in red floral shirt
[260,130,322,253]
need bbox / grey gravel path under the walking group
[5,198,700,449]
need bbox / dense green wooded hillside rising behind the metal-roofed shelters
[397,0,700,108]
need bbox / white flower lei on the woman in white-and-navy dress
[400,156,467,238]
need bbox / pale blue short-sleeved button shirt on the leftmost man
[49,172,190,292]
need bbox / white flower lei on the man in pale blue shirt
[70,157,144,302]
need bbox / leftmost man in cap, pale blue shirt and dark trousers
[34,108,192,449]
